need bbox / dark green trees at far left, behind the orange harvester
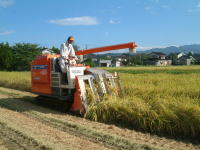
[0,43,59,71]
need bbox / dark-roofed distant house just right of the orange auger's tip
[144,52,172,66]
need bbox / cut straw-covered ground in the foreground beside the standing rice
[0,88,200,150]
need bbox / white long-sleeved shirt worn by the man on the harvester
[60,43,76,59]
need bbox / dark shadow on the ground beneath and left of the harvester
[0,96,80,116]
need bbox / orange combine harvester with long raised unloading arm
[31,42,137,113]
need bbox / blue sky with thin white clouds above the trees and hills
[0,0,200,49]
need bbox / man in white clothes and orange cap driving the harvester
[59,36,78,73]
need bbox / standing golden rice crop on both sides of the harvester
[0,66,200,140]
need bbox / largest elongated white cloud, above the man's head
[49,16,99,26]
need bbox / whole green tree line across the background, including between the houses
[0,42,200,71]
